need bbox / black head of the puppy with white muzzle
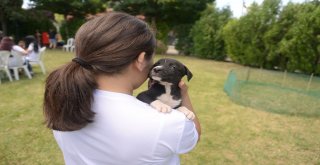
[149,58,192,84]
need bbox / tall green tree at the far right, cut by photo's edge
[280,1,320,74]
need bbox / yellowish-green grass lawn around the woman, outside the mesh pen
[0,50,320,165]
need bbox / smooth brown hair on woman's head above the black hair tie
[75,12,156,74]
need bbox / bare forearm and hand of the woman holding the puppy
[179,81,201,140]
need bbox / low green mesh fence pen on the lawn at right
[224,68,320,117]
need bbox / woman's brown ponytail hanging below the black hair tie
[43,62,97,131]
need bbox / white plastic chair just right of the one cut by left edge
[8,51,32,80]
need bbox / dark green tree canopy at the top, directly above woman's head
[114,0,214,26]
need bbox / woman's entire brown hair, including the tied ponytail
[43,12,155,131]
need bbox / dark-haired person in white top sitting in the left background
[25,35,40,75]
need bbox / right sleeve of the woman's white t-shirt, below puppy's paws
[156,111,198,155]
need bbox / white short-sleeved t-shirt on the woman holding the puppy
[53,90,198,165]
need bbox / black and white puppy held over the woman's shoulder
[137,58,195,120]
